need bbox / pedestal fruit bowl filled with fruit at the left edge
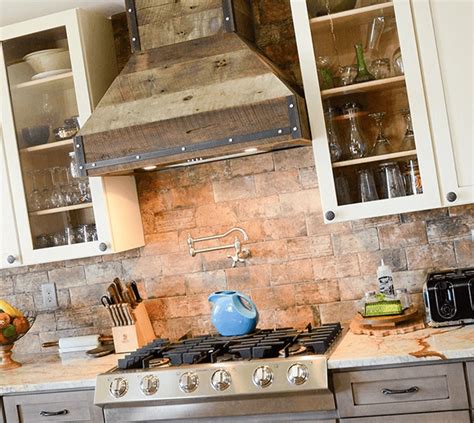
[0,300,36,370]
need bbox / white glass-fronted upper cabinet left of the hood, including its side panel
[0,9,144,264]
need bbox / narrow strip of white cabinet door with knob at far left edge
[0,124,22,269]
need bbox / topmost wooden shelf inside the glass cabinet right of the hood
[309,1,395,31]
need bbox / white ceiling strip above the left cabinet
[0,0,125,27]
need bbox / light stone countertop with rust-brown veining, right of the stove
[328,325,474,369]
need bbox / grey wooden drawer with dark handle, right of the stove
[333,363,468,417]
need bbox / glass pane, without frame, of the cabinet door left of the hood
[2,26,97,255]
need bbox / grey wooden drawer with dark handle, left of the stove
[3,391,103,423]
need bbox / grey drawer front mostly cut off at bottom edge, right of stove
[341,411,471,423]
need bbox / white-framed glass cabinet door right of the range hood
[292,0,439,224]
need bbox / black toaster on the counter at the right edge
[423,268,474,326]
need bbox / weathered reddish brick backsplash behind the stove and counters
[0,147,474,351]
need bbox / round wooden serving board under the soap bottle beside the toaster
[350,307,425,336]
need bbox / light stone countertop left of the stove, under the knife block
[0,353,123,396]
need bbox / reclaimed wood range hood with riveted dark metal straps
[74,0,311,176]
